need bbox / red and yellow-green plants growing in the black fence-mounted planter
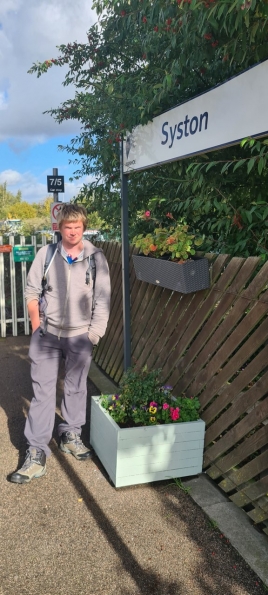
[133,211,204,262]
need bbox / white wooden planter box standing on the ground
[90,397,205,488]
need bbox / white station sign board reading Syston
[123,60,268,173]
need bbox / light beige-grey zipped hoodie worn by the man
[25,240,111,345]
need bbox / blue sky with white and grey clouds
[0,0,96,203]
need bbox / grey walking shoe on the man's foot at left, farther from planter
[10,447,46,483]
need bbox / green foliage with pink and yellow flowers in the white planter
[101,366,200,427]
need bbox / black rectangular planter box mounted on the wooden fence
[132,255,210,293]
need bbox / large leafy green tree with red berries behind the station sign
[30,0,268,258]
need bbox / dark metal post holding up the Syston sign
[120,141,131,371]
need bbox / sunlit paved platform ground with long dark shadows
[0,337,268,595]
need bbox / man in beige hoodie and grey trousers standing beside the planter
[10,204,110,483]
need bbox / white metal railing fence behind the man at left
[0,234,55,337]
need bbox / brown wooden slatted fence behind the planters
[95,243,268,534]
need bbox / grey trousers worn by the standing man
[24,329,93,456]
